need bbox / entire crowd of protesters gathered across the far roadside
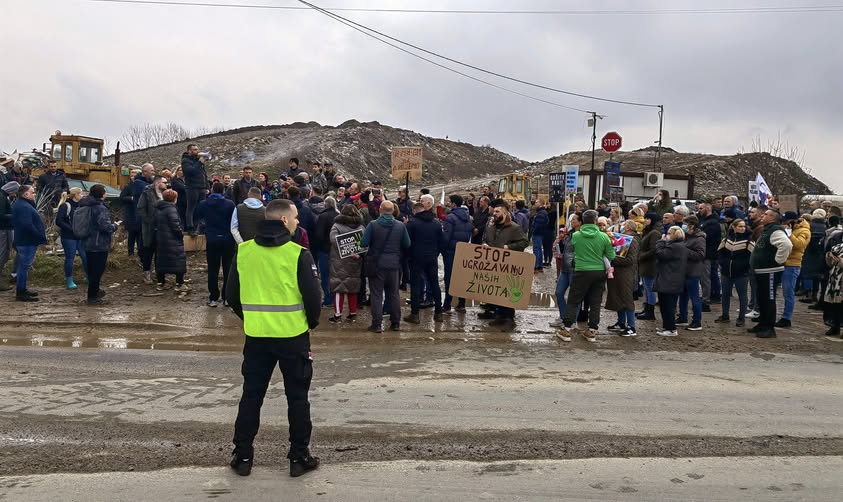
[0,145,843,341]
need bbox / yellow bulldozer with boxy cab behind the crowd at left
[32,131,131,196]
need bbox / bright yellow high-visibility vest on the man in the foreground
[237,240,308,338]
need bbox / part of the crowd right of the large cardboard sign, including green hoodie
[553,190,843,341]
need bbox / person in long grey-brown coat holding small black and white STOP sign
[328,204,363,323]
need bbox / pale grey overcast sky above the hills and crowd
[0,0,843,192]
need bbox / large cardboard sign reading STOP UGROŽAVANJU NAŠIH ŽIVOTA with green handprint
[448,242,536,310]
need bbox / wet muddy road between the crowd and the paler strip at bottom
[0,264,843,500]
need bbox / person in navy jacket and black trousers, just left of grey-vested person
[196,181,237,307]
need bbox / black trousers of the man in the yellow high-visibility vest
[234,335,313,458]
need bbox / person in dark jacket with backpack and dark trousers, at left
[76,184,118,305]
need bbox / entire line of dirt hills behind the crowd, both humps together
[112,120,831,197]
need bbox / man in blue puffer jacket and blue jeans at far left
[12,185,47,302]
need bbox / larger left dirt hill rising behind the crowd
[113,120,528,184]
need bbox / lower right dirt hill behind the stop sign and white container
[529,147,832,198]
